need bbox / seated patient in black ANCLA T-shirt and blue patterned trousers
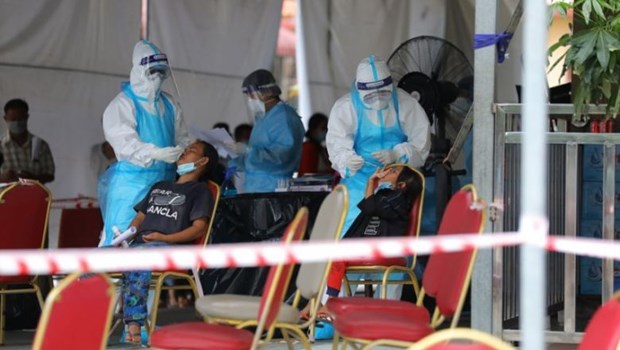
[122,140,218,344]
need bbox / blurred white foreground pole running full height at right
[519,0,549,350]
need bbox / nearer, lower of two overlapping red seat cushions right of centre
[334,311,435,342]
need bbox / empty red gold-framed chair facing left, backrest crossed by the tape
[326,185,485,347]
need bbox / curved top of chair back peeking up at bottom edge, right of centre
[407,328,514,350]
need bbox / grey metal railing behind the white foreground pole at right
[493,104,620,343]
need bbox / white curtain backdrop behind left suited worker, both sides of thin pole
[0,0,282,198]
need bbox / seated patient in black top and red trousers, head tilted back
[301,165,422,317]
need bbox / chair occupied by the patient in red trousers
[344,164,425,298]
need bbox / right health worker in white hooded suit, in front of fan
[326,56,430,233]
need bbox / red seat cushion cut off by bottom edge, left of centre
[151,322,254,350]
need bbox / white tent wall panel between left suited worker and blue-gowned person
[149,0,282,139]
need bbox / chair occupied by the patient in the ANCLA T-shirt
[147,181,221,337]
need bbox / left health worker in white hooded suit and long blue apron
[97,40,190,246]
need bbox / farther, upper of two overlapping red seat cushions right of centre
[325,297,430,324]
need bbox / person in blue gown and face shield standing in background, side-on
[231,69,305,193]
